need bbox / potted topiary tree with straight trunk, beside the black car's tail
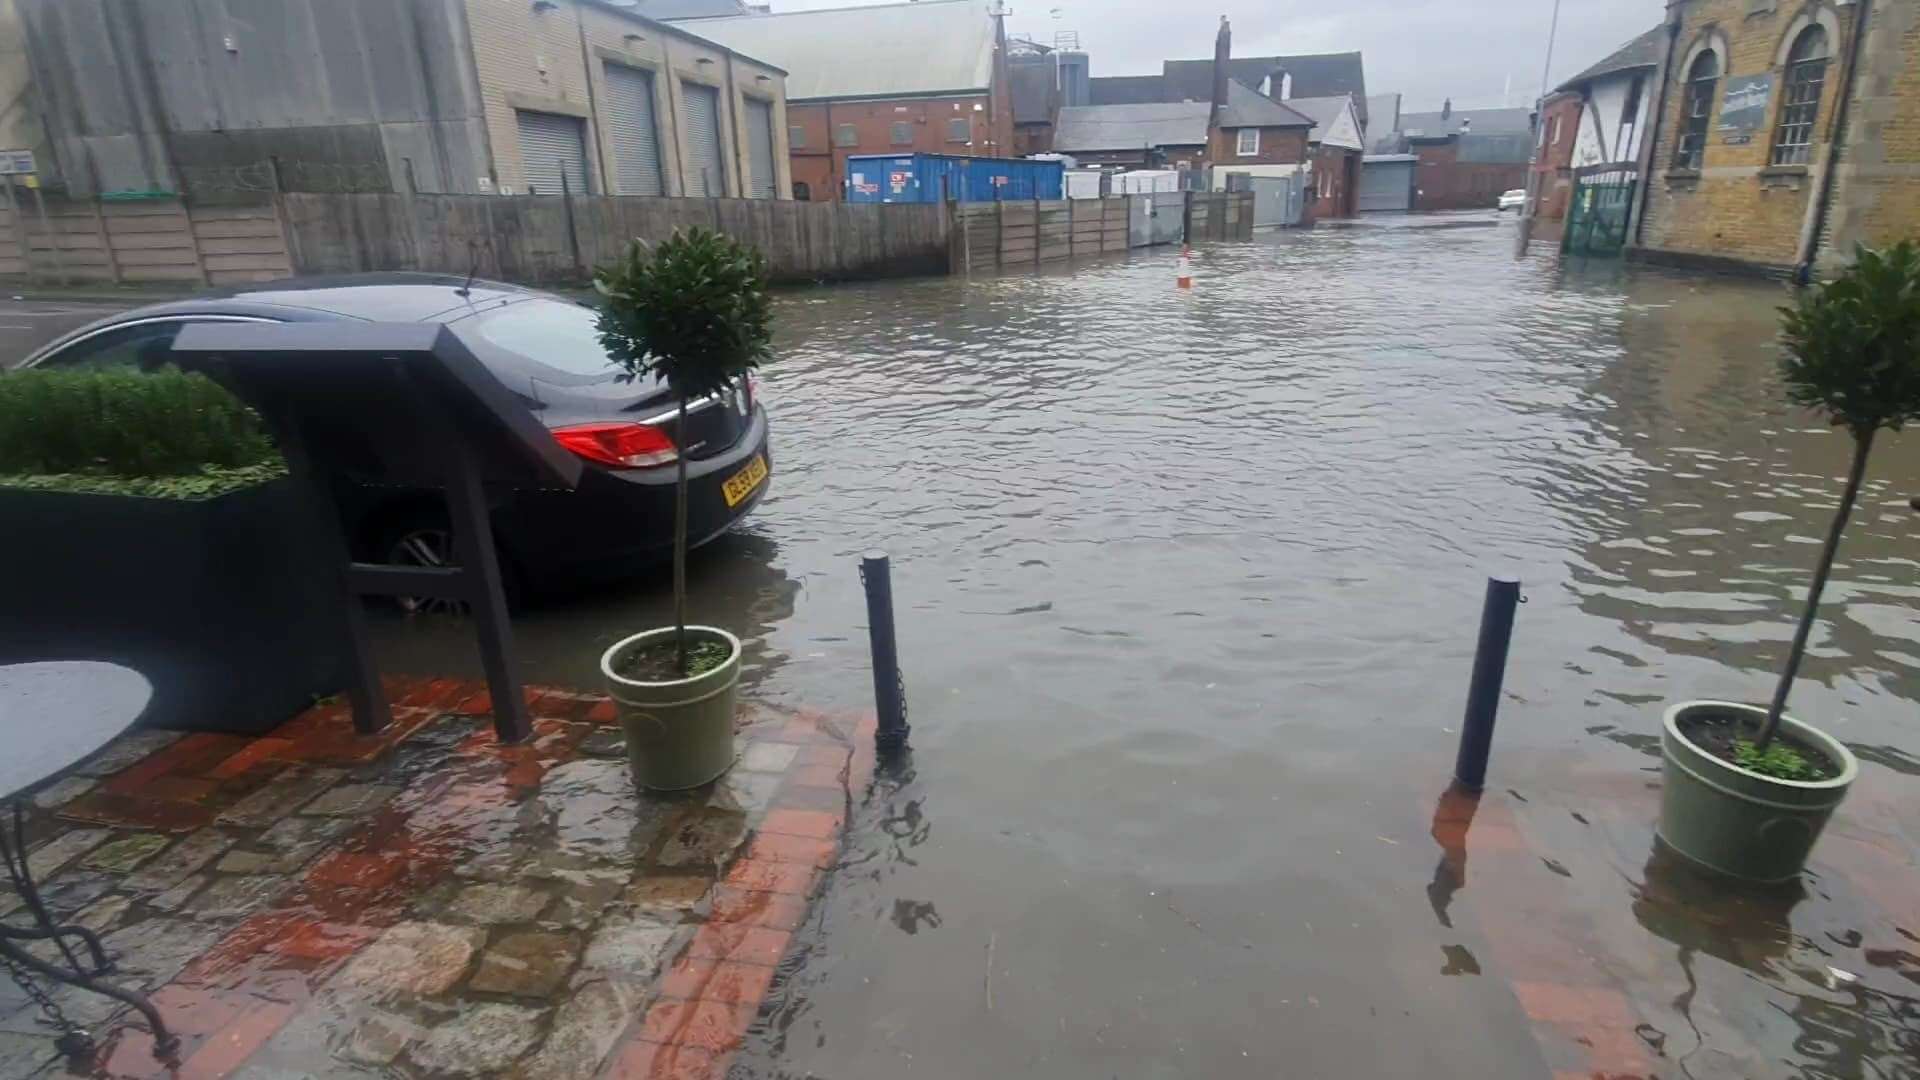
[593,229,772,792]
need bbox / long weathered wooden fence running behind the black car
[0,188,1254,284]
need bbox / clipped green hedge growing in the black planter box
[0,369,282,498]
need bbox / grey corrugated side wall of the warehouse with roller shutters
[19,0,492,202]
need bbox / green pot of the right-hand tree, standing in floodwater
[1659,701,1860,882]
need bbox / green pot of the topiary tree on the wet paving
[601,626,739,792]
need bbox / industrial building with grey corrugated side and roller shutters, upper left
[17,0,791,202]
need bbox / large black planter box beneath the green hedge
[0,480,346,734]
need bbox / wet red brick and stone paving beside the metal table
[0,680,872,1080]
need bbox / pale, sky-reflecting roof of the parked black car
[21,271,570,367]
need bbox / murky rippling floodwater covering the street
[382,219,1920,1078]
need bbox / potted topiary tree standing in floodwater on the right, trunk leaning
[1659,240,1920,882]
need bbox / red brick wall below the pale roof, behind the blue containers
[787,94,1012,202]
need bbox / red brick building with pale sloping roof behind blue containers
[674,0,1014,200]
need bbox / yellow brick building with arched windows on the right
[1636,0,1920,277]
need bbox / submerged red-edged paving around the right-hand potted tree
[1423,753,1920,1080]
